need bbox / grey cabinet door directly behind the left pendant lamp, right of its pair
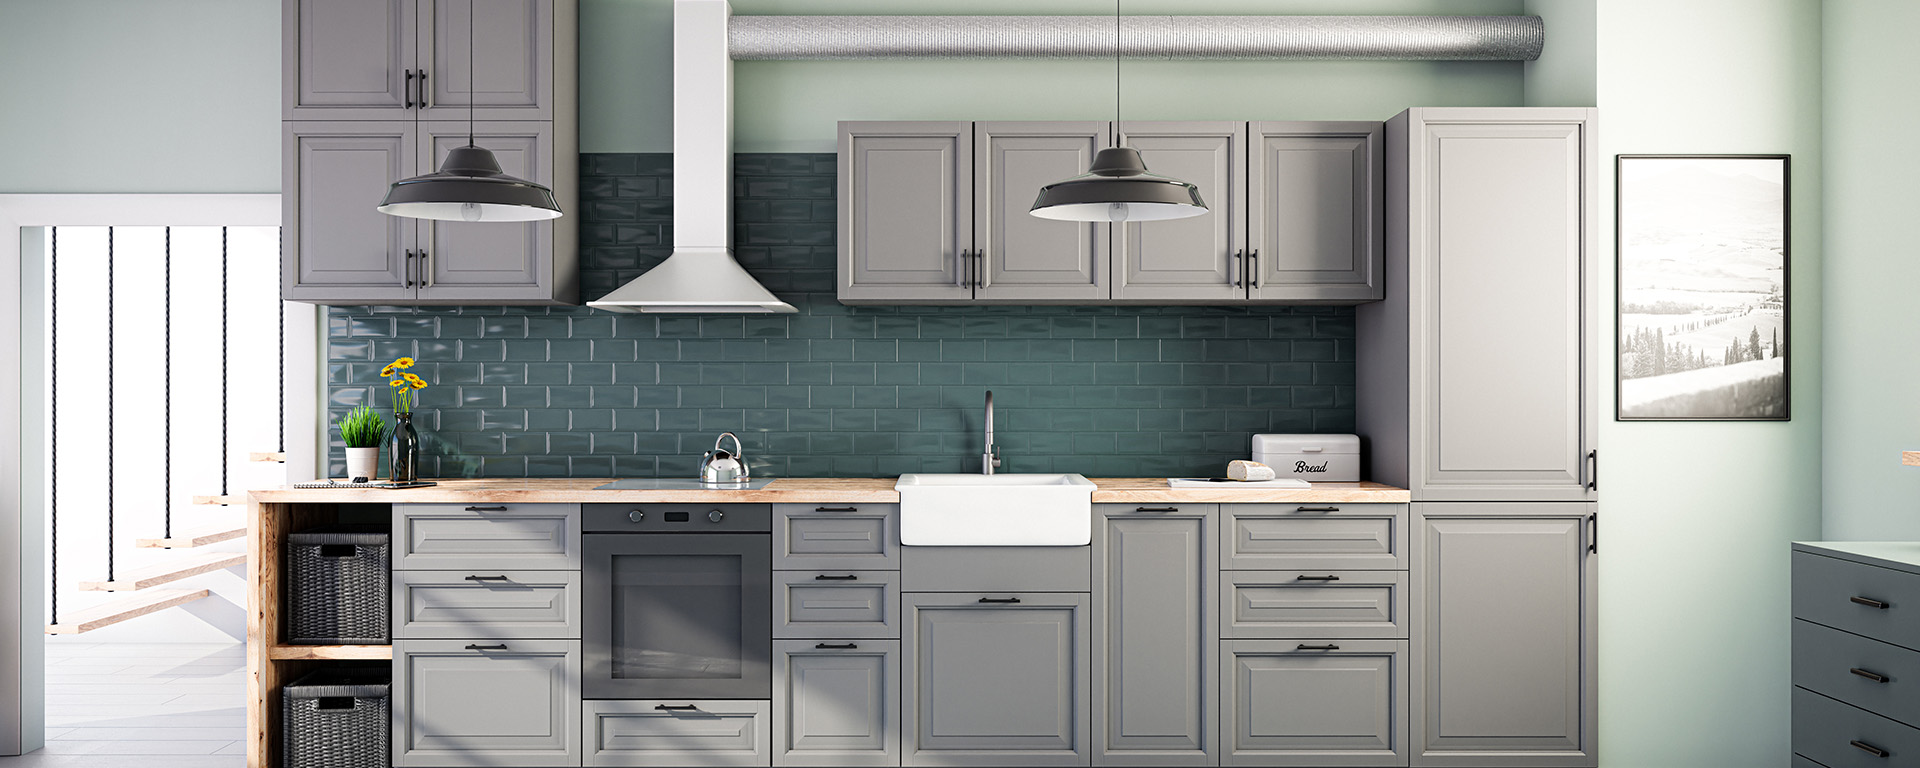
[417,121,555,301]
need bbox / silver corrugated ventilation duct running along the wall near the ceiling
[728,15,1546,61]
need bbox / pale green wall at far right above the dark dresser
[1824,0,1920,541]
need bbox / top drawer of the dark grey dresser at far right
[1793,551,1920,649]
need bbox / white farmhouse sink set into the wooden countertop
[893,474,1092,547]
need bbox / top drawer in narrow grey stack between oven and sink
[774,505,900,570]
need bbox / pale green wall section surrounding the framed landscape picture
[1597,0,1820,768]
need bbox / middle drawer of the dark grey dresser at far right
[1793,618,1920,726]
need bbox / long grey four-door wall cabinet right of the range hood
[839,121,1384,303]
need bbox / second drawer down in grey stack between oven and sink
[774,570,900,637]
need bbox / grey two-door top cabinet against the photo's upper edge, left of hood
[280,0,574,121]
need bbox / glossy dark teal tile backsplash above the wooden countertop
[326,154,1354,476]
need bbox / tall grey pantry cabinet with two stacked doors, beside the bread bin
[1356,108,1601,768]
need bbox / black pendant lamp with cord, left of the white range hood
[378,0,561,221]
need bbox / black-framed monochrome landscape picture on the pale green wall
[1615,156,1791,420]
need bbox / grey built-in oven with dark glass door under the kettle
[582,503,774,699]
